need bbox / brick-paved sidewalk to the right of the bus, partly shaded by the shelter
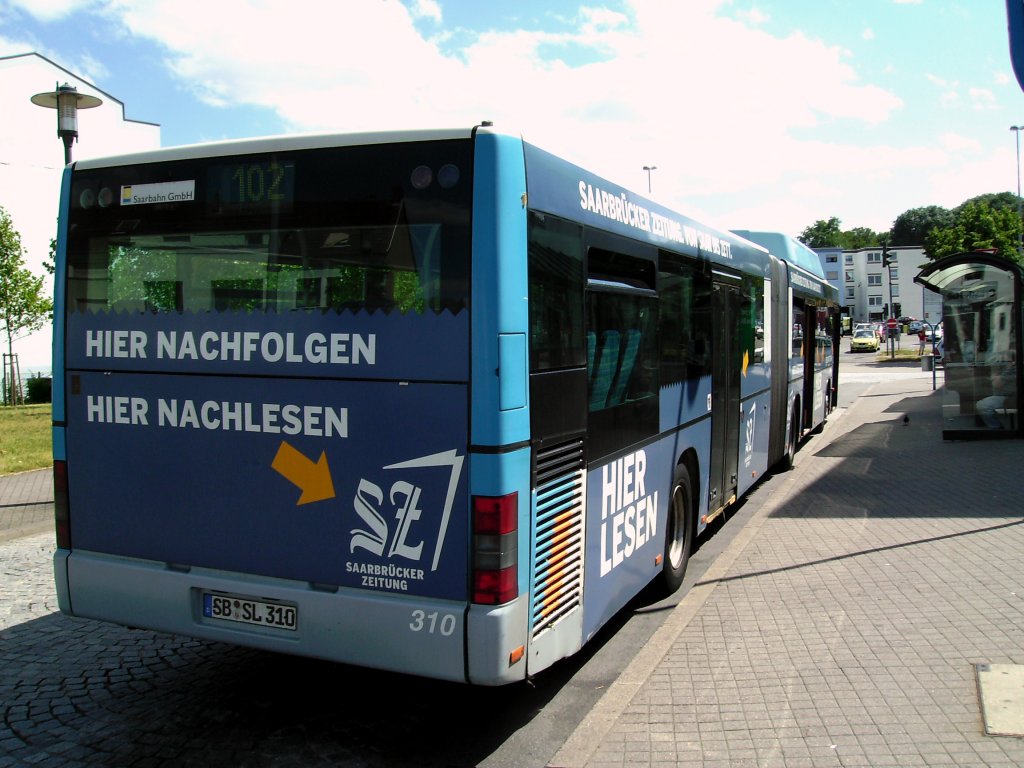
[550,375,1024,768]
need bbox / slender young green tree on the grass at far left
[0,208,53,404]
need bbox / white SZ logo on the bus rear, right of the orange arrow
[349,451,464,578]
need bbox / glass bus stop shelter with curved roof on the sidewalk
[913,251,1024,440]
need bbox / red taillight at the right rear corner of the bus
[473,494,519,605]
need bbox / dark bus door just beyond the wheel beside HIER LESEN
[708,271,740,518]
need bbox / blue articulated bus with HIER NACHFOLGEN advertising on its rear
[53,124,839,685]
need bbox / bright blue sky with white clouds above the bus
[0,0,1024,370]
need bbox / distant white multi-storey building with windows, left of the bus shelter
[815,246,942,324]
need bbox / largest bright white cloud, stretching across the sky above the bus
[24,0,994,234]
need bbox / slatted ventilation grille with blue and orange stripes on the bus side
[531,440,587,638]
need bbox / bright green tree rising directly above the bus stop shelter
[924,199,1021,261]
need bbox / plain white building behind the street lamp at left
[0,53,160,376]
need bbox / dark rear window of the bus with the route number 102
[68,142,471,313]
